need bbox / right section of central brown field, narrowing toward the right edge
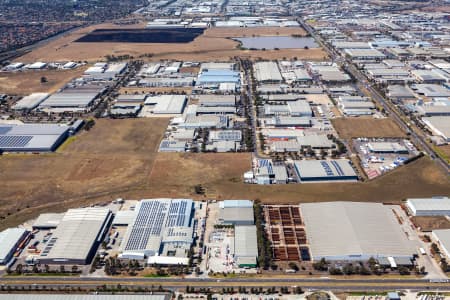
[150,154,450,204]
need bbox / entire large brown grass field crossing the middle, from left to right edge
[0,118,450,228]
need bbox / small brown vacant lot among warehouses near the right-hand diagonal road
[331,117,406,139]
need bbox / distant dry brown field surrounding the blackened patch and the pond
[17,24,327,62]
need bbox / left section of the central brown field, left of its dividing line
[0,118,168,230]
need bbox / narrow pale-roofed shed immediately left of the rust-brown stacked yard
[234,225,258,268]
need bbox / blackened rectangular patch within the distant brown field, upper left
[75,28,204,43]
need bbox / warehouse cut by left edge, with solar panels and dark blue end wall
[0,124,70,152]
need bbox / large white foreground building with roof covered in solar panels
[120,198,194,264]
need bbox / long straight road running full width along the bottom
[0,277,450,291]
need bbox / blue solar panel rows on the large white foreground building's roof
[124,199,192,251]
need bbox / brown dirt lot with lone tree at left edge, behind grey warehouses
[0,67,86,95]
